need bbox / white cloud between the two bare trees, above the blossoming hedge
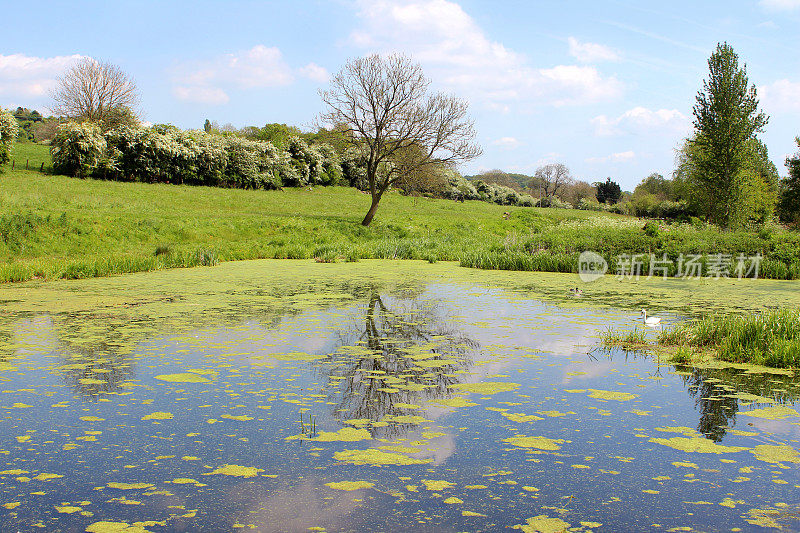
[173,44,294,104]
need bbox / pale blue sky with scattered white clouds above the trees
[0,0,800,190]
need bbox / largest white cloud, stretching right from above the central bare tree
[349,0,623,111]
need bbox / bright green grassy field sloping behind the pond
[0,144,800,281]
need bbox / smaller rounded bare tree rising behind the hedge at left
[51,57,139,127]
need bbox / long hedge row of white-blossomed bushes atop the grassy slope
[50,122,360,189]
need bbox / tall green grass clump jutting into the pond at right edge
[659,309,800,368]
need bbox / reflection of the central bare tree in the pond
[320,290,479,438]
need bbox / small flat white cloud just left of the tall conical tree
[591,107,689,137]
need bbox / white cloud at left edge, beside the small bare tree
[0,54,82,105]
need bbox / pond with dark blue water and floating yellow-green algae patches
[0,261,800,532]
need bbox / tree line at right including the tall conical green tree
[470,43,800,229]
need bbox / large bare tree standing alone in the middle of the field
[319,54,481,226]
